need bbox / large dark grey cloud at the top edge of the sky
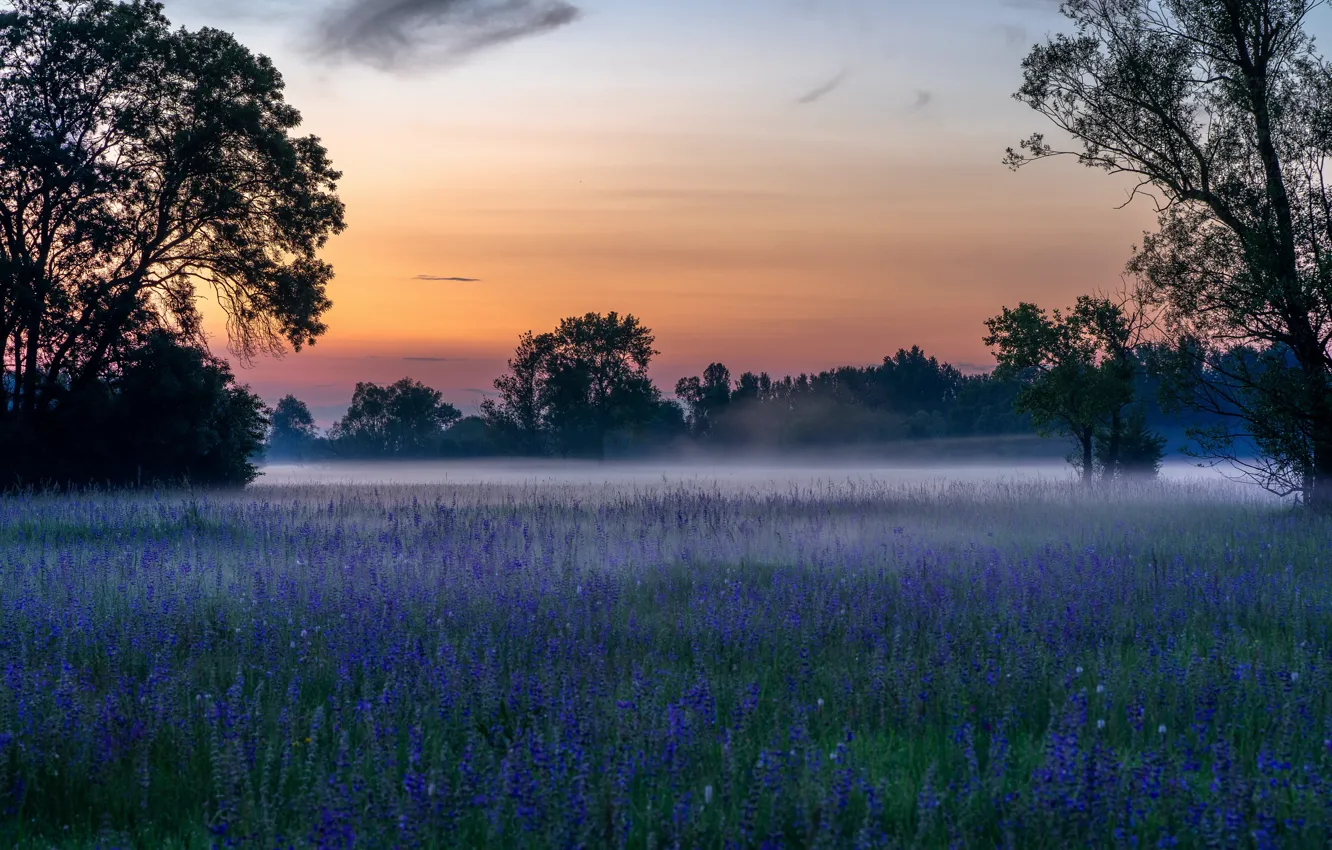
[314,0,581,68]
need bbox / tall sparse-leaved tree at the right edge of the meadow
[1008,0,1332,510]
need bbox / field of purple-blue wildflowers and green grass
[0,482,1332,849]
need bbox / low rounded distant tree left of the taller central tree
[329,378,462,457]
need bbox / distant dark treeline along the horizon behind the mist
[266,313,1034,461]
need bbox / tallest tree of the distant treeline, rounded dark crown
[482,312,661,457]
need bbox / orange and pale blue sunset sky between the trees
[167,0,1155,425]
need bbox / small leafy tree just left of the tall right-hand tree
[984,296,1136,484]
